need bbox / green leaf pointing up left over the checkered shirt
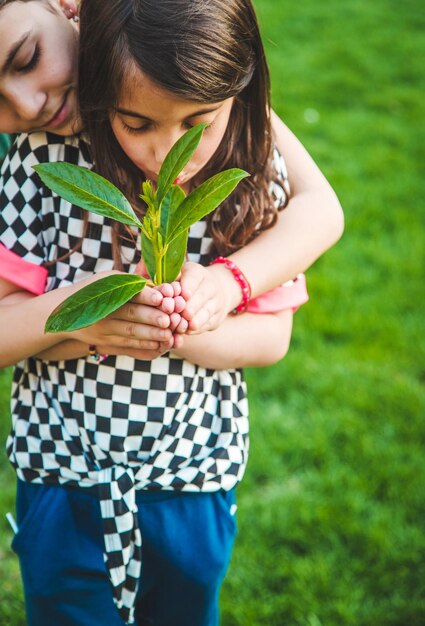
[34,163,141,228]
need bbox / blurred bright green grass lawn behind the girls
[0,0,425,626]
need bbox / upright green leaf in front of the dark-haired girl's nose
[157,124,208,206]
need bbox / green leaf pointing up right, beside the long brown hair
[168,168,249,241]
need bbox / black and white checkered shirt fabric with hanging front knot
[0,133,289,623]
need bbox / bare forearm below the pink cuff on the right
[173,311,293,369]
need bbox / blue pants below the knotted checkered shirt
[12,480,236,626]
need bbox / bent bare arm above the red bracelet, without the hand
[231,112,344,297]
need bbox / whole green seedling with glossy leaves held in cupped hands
[34,124,248,332]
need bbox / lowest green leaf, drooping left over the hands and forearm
[44,274,146,333]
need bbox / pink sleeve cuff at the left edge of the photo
[0,244,48,296]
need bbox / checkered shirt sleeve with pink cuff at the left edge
[0,135,48,294]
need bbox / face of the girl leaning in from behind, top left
[0,0,79,135]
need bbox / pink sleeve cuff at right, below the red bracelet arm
[246,274,308,313]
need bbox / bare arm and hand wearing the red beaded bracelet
[182,113,344,332]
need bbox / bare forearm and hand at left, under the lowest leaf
[0,273,181,368]
